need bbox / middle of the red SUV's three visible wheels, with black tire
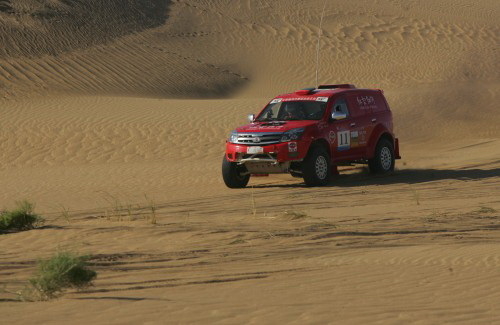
[302,146,331,186]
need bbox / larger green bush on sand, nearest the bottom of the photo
[30,252,97,300]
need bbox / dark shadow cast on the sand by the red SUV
[253,168,500,188]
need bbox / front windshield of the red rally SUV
[256,101,326,122]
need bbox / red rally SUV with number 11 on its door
[222,84,401,188]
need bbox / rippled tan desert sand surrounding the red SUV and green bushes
[0,0,500,324]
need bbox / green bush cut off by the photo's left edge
[0,201,43,230]
